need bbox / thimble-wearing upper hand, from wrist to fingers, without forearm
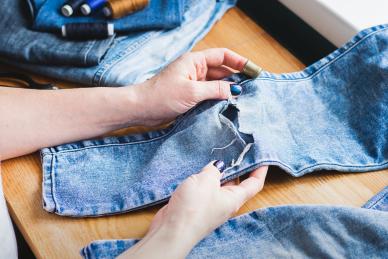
[130,48,247,126]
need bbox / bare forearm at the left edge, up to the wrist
[0,86,141,160]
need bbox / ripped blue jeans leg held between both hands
[41,25,388,217]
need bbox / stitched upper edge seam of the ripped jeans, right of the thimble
[252,27,388,83]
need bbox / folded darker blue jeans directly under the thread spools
[27,0,185,33]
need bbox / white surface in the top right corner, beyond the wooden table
[279,0,388,47]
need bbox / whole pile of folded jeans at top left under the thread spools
[0,0,236,86]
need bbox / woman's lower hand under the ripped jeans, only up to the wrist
[150,163,268,243]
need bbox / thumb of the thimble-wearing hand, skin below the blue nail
[193,80,231,102]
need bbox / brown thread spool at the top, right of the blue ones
[103,0,149,19]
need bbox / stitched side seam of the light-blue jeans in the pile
[92,31,159,86]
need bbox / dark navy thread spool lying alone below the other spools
[61,23,114,40]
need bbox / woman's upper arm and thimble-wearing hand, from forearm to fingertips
[0,49,247,160]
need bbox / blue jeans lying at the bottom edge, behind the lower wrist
[81,187,388,259]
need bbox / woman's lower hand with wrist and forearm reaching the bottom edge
[122,162,268,258]
